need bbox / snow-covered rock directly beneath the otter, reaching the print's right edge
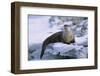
[48,37,88,58]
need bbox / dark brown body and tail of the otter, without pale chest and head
[40,31,75,59]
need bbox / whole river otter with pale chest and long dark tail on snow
[40,25,75,59]
